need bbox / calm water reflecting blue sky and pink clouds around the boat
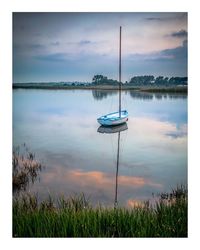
[13,89,187,206]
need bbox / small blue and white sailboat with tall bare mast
[97,26,128,126]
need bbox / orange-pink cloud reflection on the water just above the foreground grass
[38,165,163,207]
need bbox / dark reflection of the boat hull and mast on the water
[97,123,128,208]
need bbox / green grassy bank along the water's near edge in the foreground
[13,187,187,237]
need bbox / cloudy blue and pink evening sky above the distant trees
[13,12,188,82]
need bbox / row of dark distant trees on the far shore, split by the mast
[92,75,188,85]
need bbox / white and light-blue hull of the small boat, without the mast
[97,110,128,126]
